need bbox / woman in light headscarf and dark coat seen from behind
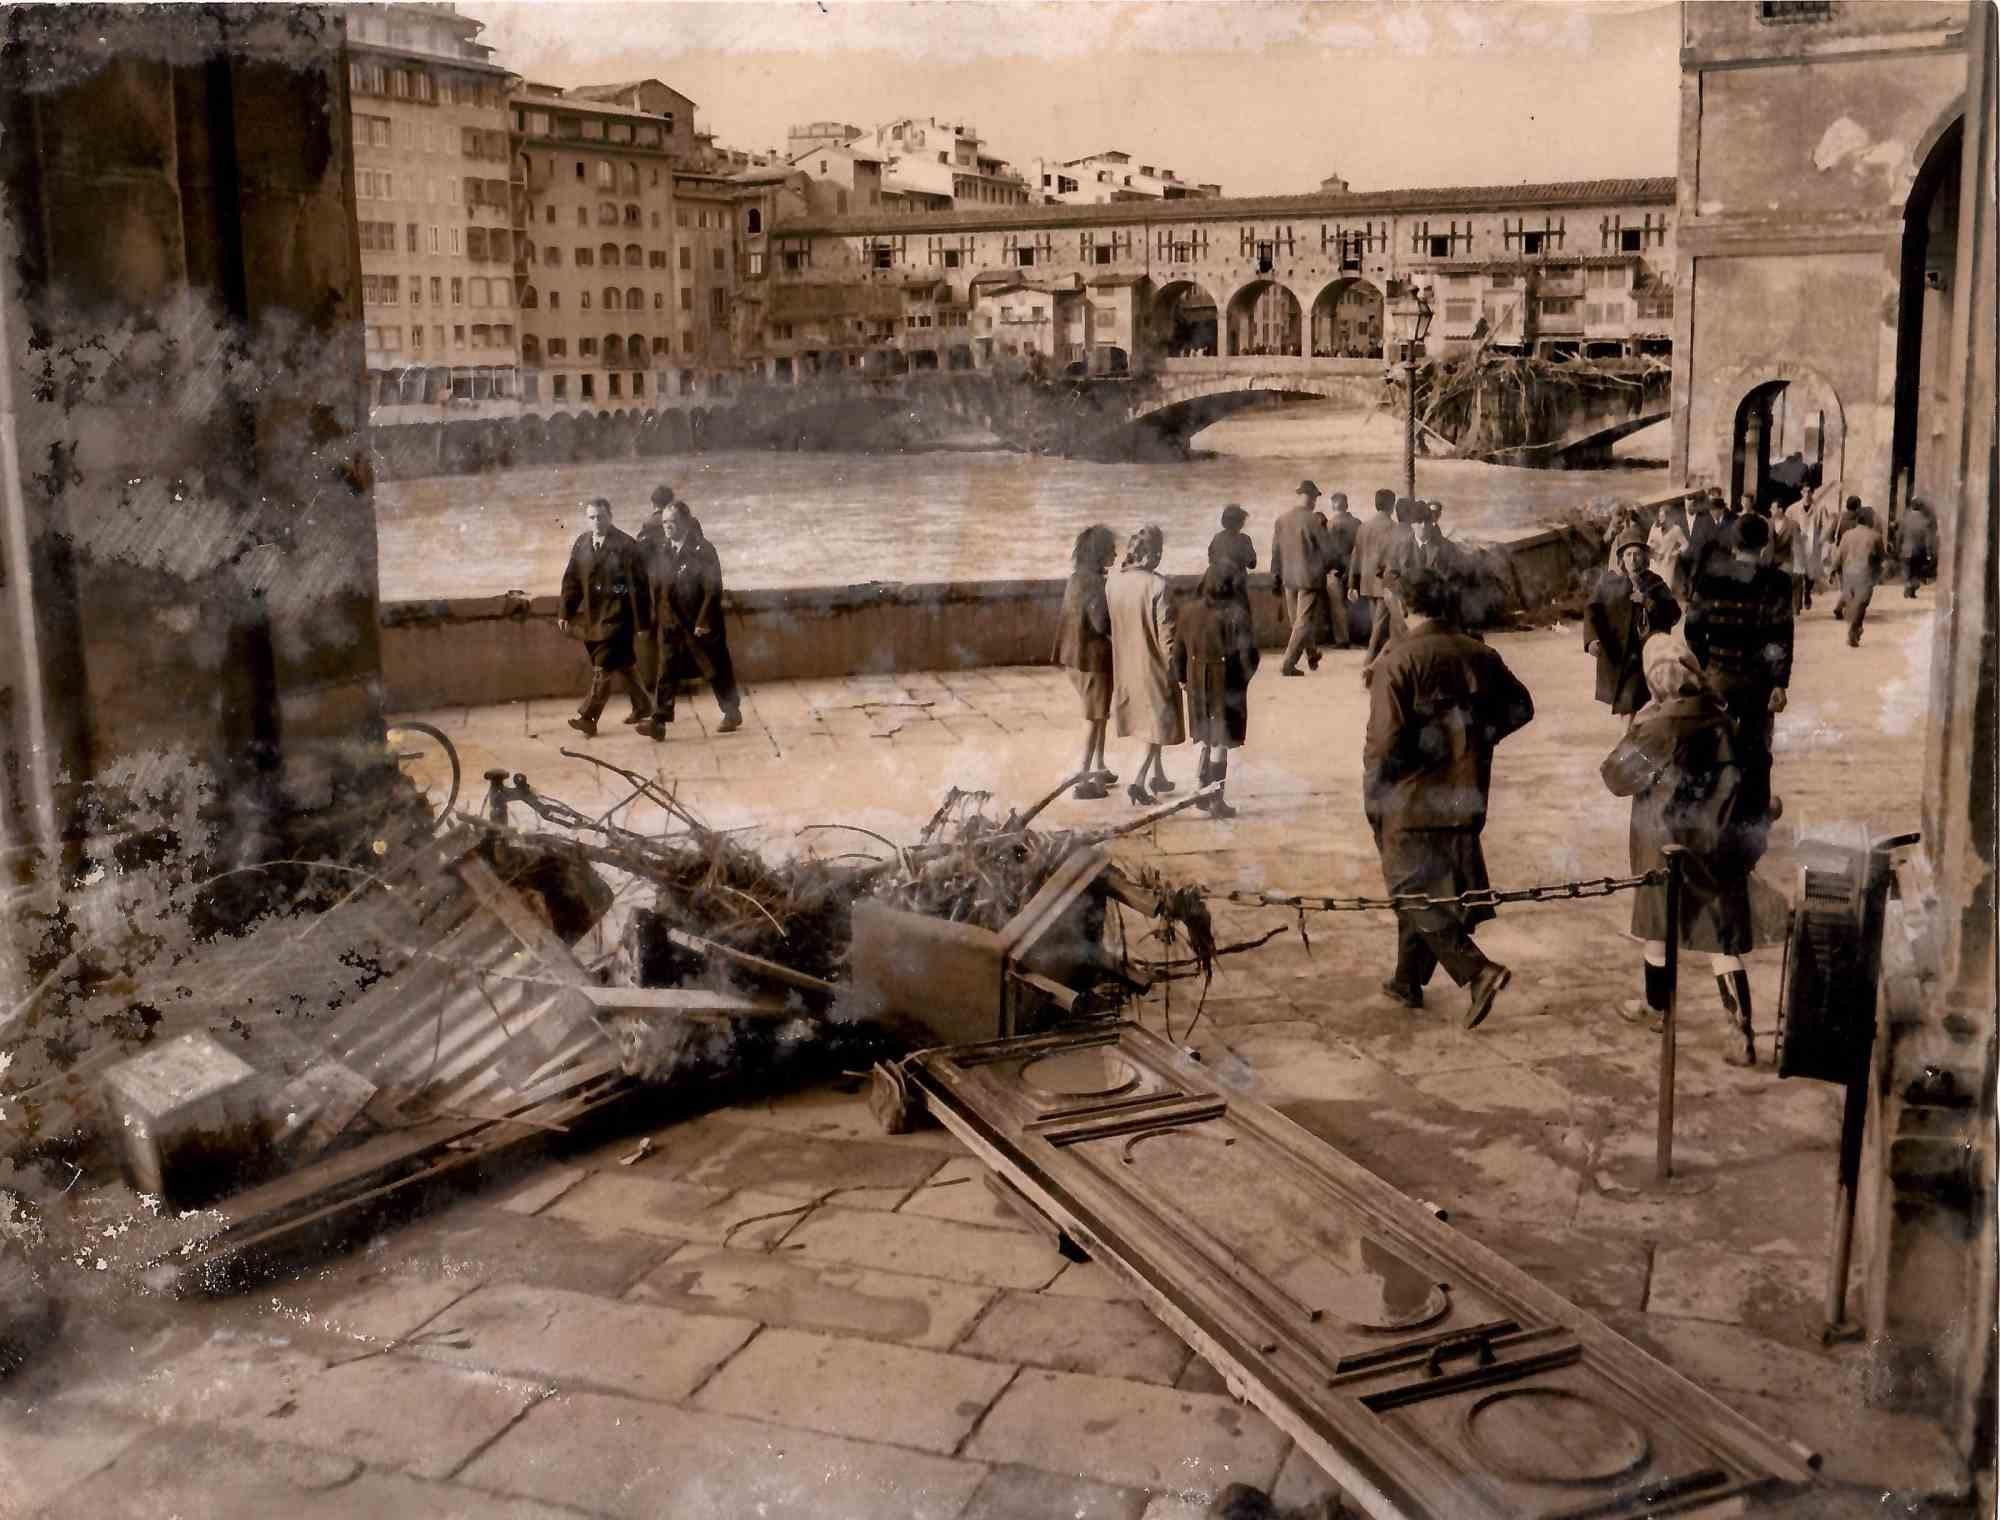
[1604,634,1770,1066]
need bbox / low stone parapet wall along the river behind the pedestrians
[382,526,1604,712]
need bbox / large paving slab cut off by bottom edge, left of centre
[462,1394,986,1520]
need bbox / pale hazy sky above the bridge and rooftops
[476,0,1680,194]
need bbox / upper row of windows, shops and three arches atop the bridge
[772,178,1676,372]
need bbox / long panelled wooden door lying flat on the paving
[912,1024,1814,1520]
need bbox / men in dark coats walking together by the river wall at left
[556,486,744,740]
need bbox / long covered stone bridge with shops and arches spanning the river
[744,178,1674,452]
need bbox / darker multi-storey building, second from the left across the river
[510,80,694,416]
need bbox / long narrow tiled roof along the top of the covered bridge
[776,176,1676,234]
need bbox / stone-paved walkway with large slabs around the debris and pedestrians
[0,596,1958,1520]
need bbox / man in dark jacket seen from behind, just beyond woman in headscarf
[1682,518,1792,818]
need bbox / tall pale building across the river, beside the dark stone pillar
[344,4,520,424]
